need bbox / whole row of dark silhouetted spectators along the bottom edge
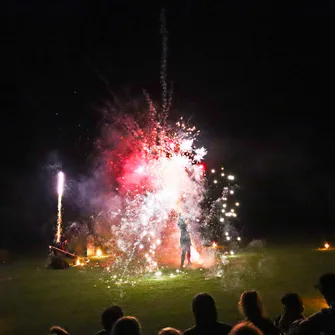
[49,273,335,335]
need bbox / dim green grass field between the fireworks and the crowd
[0,247,335,335]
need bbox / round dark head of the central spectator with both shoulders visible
[192,293,217,325]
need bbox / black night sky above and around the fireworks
[0,0,335,247]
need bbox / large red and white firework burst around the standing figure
[79,103,240,273]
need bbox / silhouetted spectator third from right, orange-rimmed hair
[239,291,280,335]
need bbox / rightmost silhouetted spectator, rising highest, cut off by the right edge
[289,273,335,335]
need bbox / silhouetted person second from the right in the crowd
[274,293,304,334]
